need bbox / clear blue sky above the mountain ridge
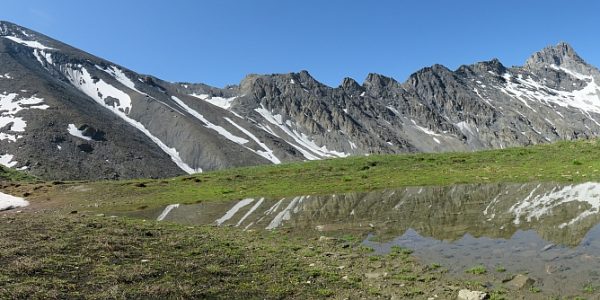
[0,0,600,87]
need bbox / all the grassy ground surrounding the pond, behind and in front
[0,140,600,299]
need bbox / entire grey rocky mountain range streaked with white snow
[0,22,600,179]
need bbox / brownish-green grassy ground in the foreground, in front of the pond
[0,203,580,299]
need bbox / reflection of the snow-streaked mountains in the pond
[128,182,600,246]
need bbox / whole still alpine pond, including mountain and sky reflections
[119,182,600,292]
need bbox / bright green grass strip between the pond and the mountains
[26,140,600,210]
